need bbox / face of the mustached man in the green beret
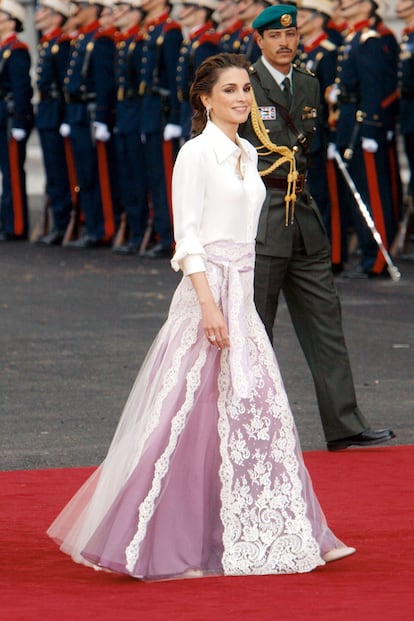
[257,28,299,74]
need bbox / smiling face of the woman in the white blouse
[201,67,252,128]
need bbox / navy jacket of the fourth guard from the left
[115,25,143,133]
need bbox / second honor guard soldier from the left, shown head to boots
[35,0,72,246]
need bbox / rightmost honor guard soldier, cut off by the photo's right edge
[396,0,414,209]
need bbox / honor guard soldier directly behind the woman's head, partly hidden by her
[177,0,219,140]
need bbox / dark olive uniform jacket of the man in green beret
[240,59,329,257]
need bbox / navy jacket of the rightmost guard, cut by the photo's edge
[398,26,414,134]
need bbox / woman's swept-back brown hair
[190,54,250,136]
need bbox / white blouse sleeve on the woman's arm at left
[171,140,206,276]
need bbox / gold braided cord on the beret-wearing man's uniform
[250,90,299,226]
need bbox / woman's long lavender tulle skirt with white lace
[48,242,344,580]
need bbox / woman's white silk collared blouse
[171,121,266,275]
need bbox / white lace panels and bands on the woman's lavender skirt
[126,243,323,575]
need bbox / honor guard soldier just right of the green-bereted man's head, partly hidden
[297,0,337,253]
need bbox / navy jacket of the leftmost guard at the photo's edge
[0,33,33,132]
